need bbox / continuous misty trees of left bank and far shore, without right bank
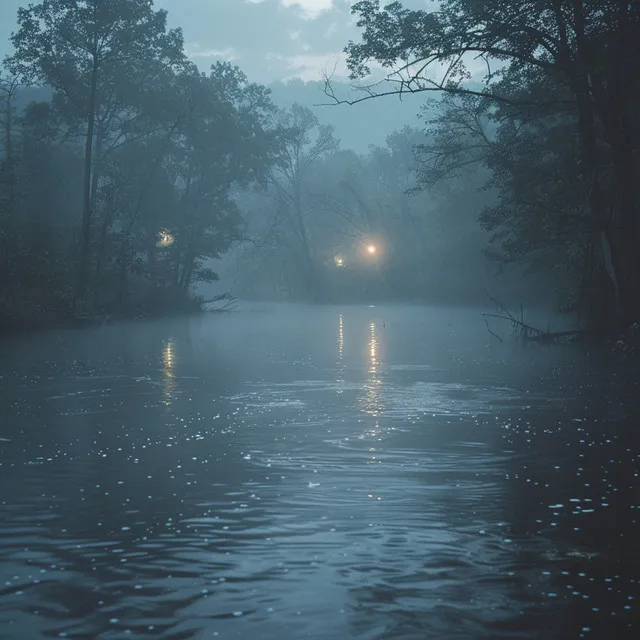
[0,0,504,326]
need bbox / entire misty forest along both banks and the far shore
[0,0,640,336]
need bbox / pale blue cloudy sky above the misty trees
[0,0,430,84]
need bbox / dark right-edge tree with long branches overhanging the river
[329,0,640,325]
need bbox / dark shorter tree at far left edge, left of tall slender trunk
[0,97,82,326]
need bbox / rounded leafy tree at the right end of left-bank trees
[172,63,276,292]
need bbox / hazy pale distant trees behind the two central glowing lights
[225,121,495,304]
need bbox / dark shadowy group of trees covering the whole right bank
[336,0,640,328]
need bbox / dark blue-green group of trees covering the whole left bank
[0,0,286,325]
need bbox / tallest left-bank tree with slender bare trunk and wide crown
[8,0,184,310]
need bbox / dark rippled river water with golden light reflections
[0,306,640,640]
